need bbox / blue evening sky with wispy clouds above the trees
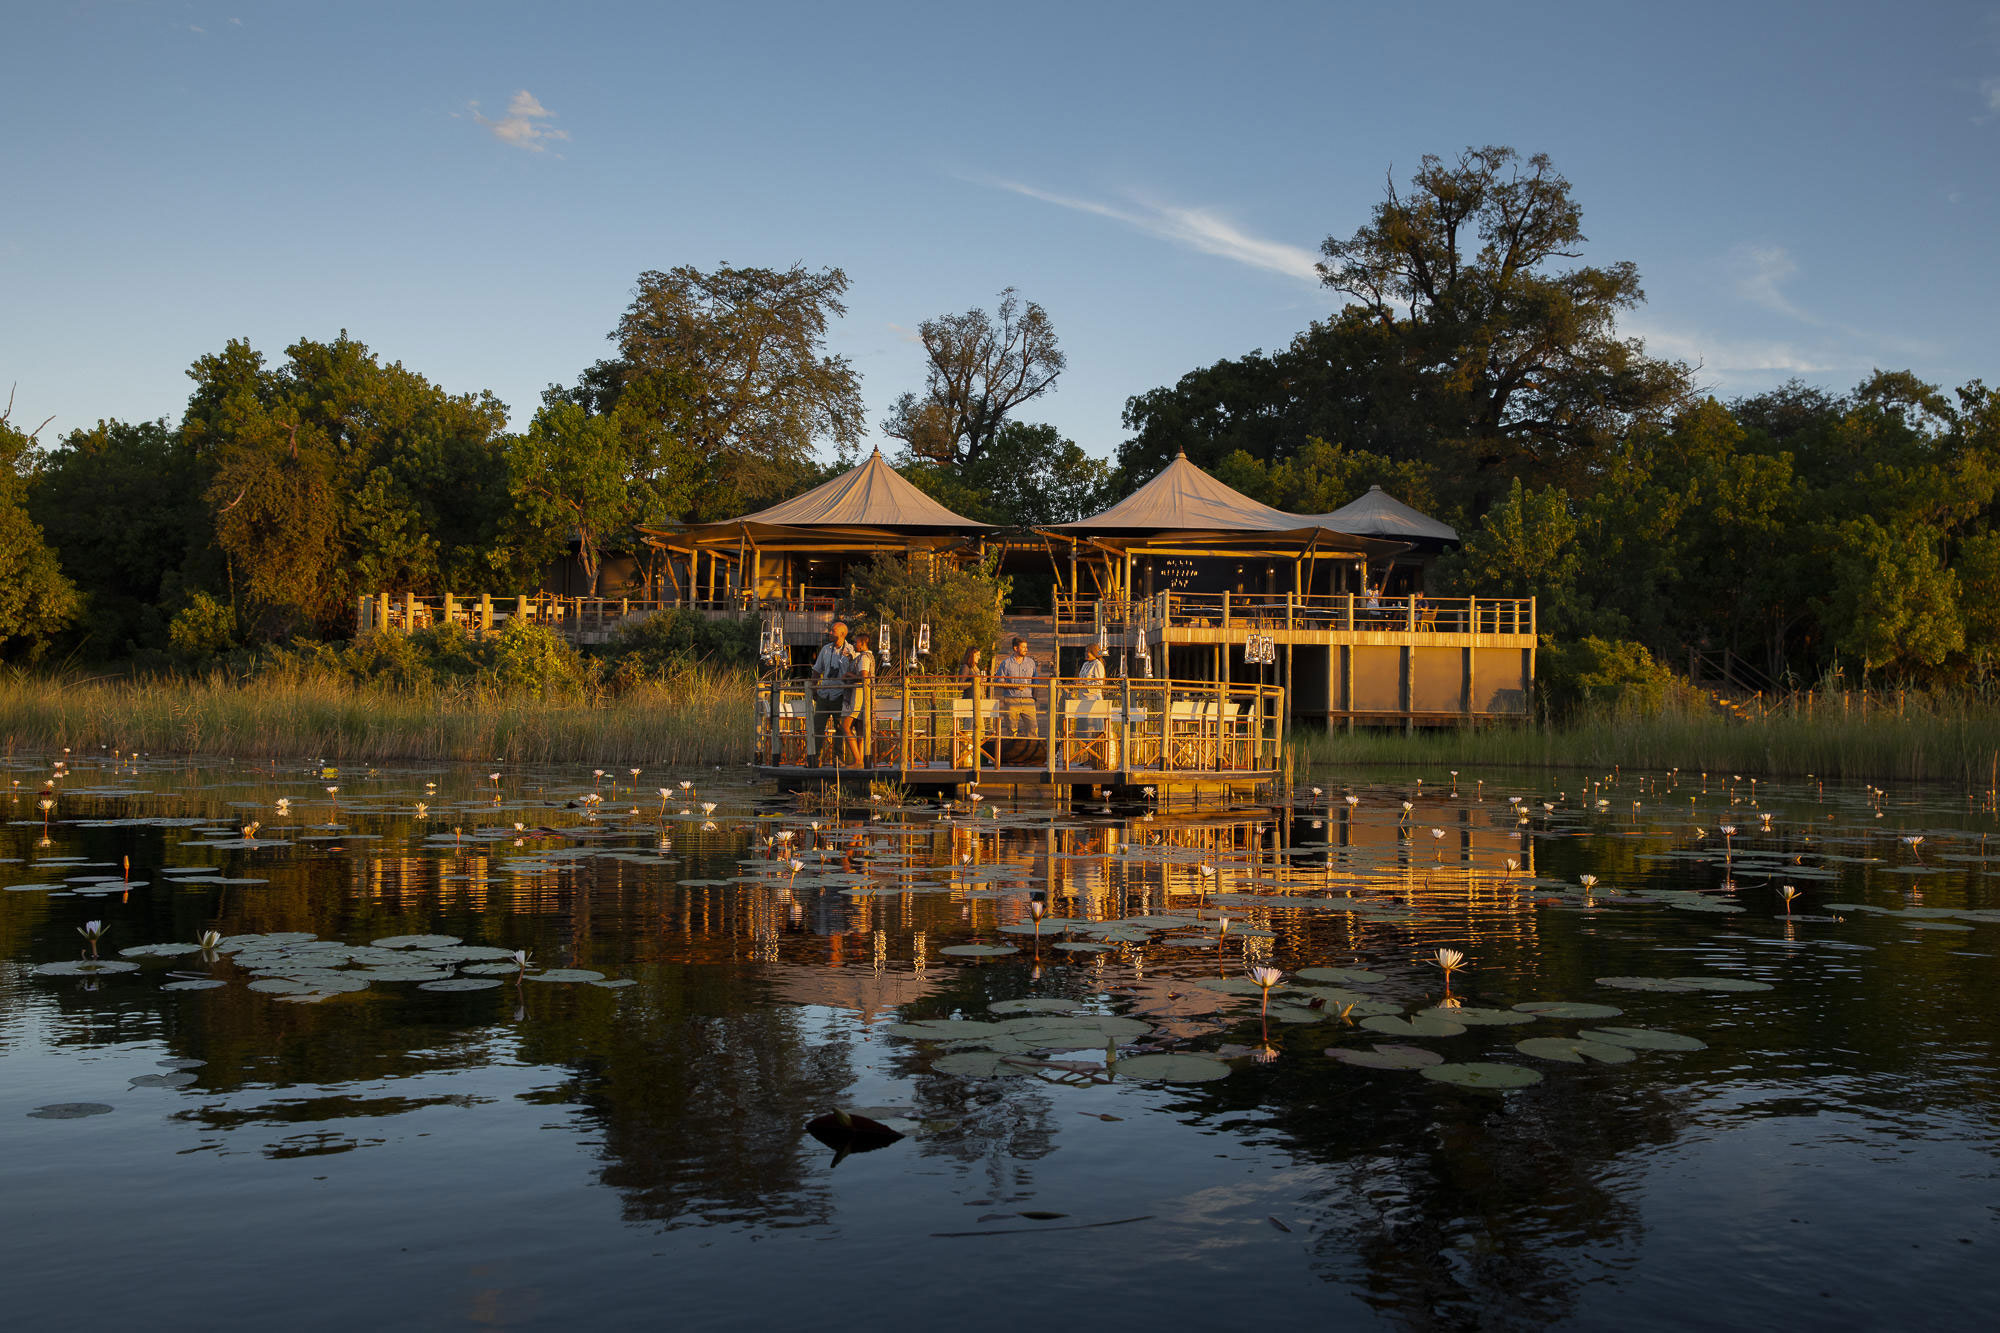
[0,0,2000,454]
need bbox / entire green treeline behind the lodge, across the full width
[0,148,2000,685]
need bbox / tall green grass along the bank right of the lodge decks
[1292,697,2000,793]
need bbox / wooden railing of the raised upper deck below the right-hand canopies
[1056,592,1536,634]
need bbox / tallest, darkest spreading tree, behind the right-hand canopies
[1118,148,1690,518]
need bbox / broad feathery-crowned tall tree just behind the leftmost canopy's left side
[608,264,862,516]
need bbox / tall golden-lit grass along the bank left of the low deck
[0,671,754,765]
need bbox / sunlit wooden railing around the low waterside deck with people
[756,675,1284,781]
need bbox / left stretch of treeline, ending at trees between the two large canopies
[0,266,1110,664]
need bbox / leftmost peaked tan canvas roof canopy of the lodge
[644,450,992,546]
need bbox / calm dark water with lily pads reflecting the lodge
[0,757,2000,1329]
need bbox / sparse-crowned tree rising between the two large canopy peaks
[882,286,1068,468]
